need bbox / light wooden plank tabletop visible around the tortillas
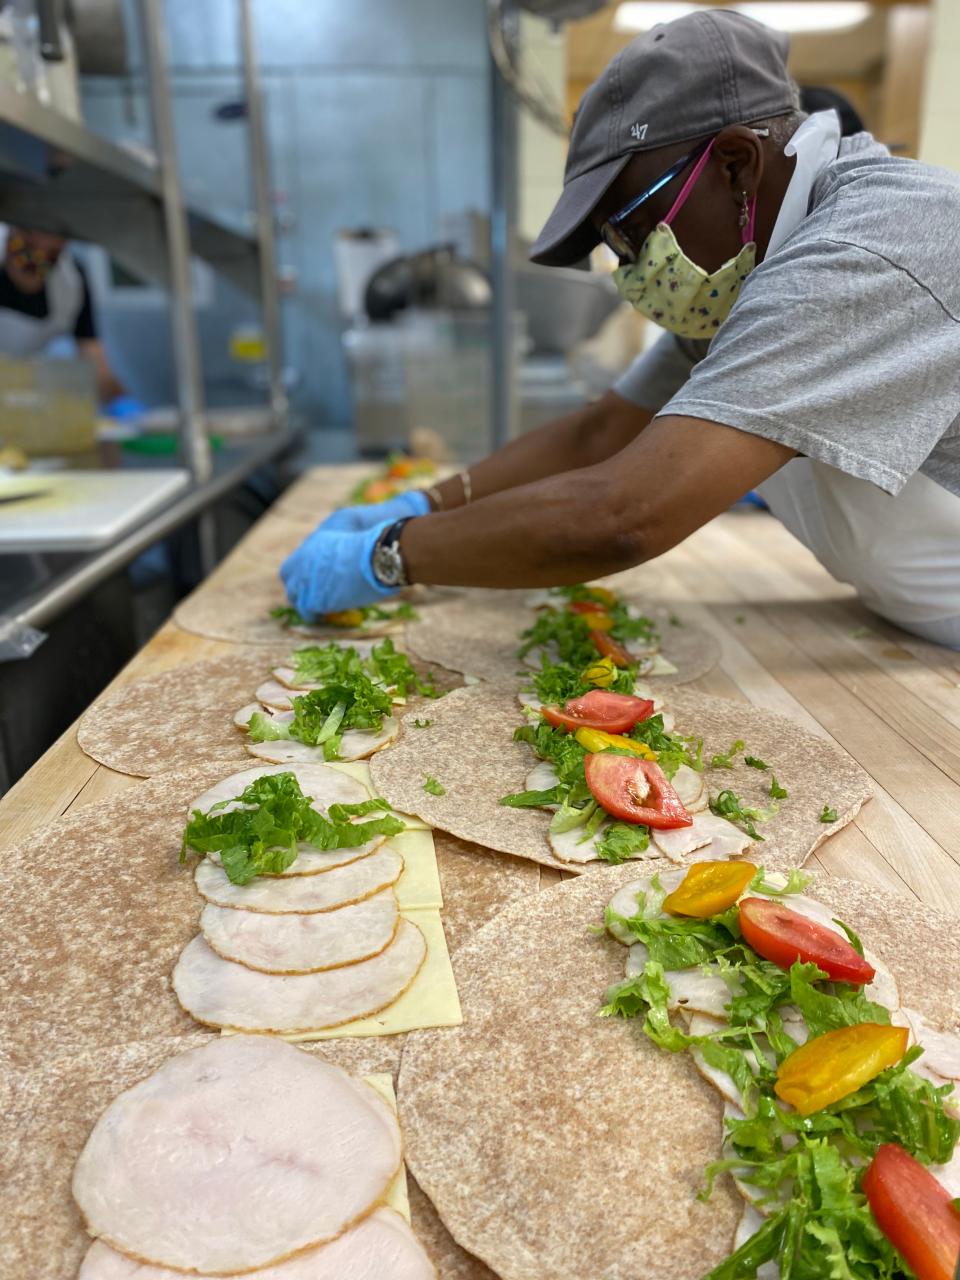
[0,466,960,913]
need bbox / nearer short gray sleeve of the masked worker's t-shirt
[660,238,960,494]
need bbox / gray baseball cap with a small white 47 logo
[530,9,796,266]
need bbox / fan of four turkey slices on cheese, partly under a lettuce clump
[173,764,426,1034]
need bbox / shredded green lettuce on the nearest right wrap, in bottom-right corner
[599,869,960,1280]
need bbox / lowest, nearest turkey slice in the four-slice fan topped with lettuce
[173,920,426,1036]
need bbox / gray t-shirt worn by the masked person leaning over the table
[614,133,960,495]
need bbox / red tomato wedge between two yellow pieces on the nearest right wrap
[740,897,877,986]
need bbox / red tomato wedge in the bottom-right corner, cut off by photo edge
[863,1143,960,1280]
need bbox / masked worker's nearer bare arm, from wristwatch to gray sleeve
[401,416,795,588]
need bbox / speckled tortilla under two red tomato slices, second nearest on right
[370,685,870,870]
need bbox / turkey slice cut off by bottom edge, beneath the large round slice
[77,1208,436,1280]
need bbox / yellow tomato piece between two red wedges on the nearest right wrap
[773,1023,910,1116]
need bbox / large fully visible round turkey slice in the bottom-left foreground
[73,1036,401,1275]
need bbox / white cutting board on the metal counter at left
[0,467,189,553]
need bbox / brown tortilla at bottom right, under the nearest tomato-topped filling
[398,864,960,1280]
